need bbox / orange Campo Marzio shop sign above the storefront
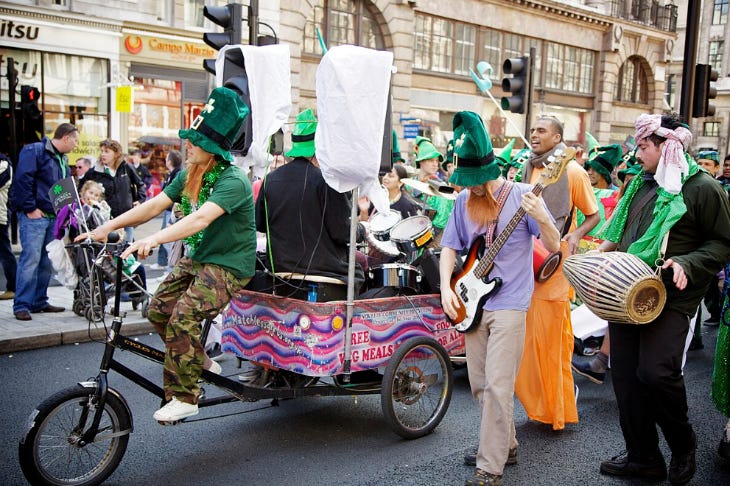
[123,34,216,64]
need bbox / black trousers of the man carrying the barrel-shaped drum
[609,310,693,462]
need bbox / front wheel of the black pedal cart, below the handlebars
[18,385,132,486]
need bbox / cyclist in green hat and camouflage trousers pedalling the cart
[76,87,256,423]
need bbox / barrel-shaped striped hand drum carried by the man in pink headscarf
[563,251,667,324]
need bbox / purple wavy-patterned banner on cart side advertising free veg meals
[221,291,465,377]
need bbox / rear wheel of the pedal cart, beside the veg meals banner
[380,336,454,439]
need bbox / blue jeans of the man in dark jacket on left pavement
[13,213,56,313]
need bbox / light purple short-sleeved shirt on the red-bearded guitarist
[441,183,554,311]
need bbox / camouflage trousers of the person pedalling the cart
[147,257,250,403]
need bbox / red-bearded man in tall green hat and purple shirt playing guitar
[440,111,560,485]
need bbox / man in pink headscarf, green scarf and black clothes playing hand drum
[599,114,730,484]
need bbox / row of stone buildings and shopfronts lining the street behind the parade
[5,0,716,173]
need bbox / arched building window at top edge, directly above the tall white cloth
[303,0,385,54]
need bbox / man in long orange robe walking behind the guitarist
[515,115,599,430]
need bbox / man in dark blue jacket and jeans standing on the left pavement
[10,123,79,321]
